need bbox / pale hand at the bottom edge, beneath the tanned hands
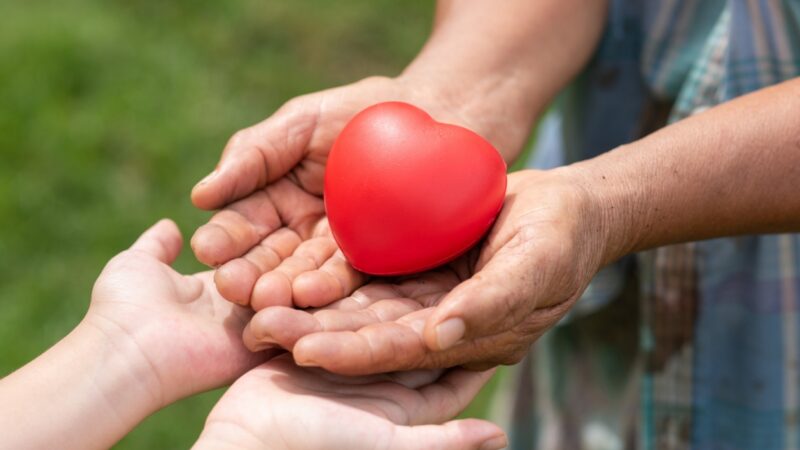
[195,355,506,450]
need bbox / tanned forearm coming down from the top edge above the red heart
[402,0,607,161]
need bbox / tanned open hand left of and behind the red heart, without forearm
[192,77,490,309]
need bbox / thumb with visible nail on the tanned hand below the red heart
[423,243,535,351]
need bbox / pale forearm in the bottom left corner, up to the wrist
[0,325,159,449]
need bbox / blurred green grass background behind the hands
[0,0,506,449]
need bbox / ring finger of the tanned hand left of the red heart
[251,237,336,311]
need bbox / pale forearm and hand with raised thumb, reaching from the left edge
[0,221,266,449]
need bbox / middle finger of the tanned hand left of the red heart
[214,228,301,305]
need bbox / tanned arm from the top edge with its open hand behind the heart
[192,0,606,309]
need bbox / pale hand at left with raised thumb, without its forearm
[81,220,264,407]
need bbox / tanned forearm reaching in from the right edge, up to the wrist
[566,79,800,259]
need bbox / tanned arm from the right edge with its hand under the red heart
[245,79,800,374]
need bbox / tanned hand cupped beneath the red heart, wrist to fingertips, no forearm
[245,171,606,374]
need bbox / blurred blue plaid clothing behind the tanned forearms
[504,0,800,450]
